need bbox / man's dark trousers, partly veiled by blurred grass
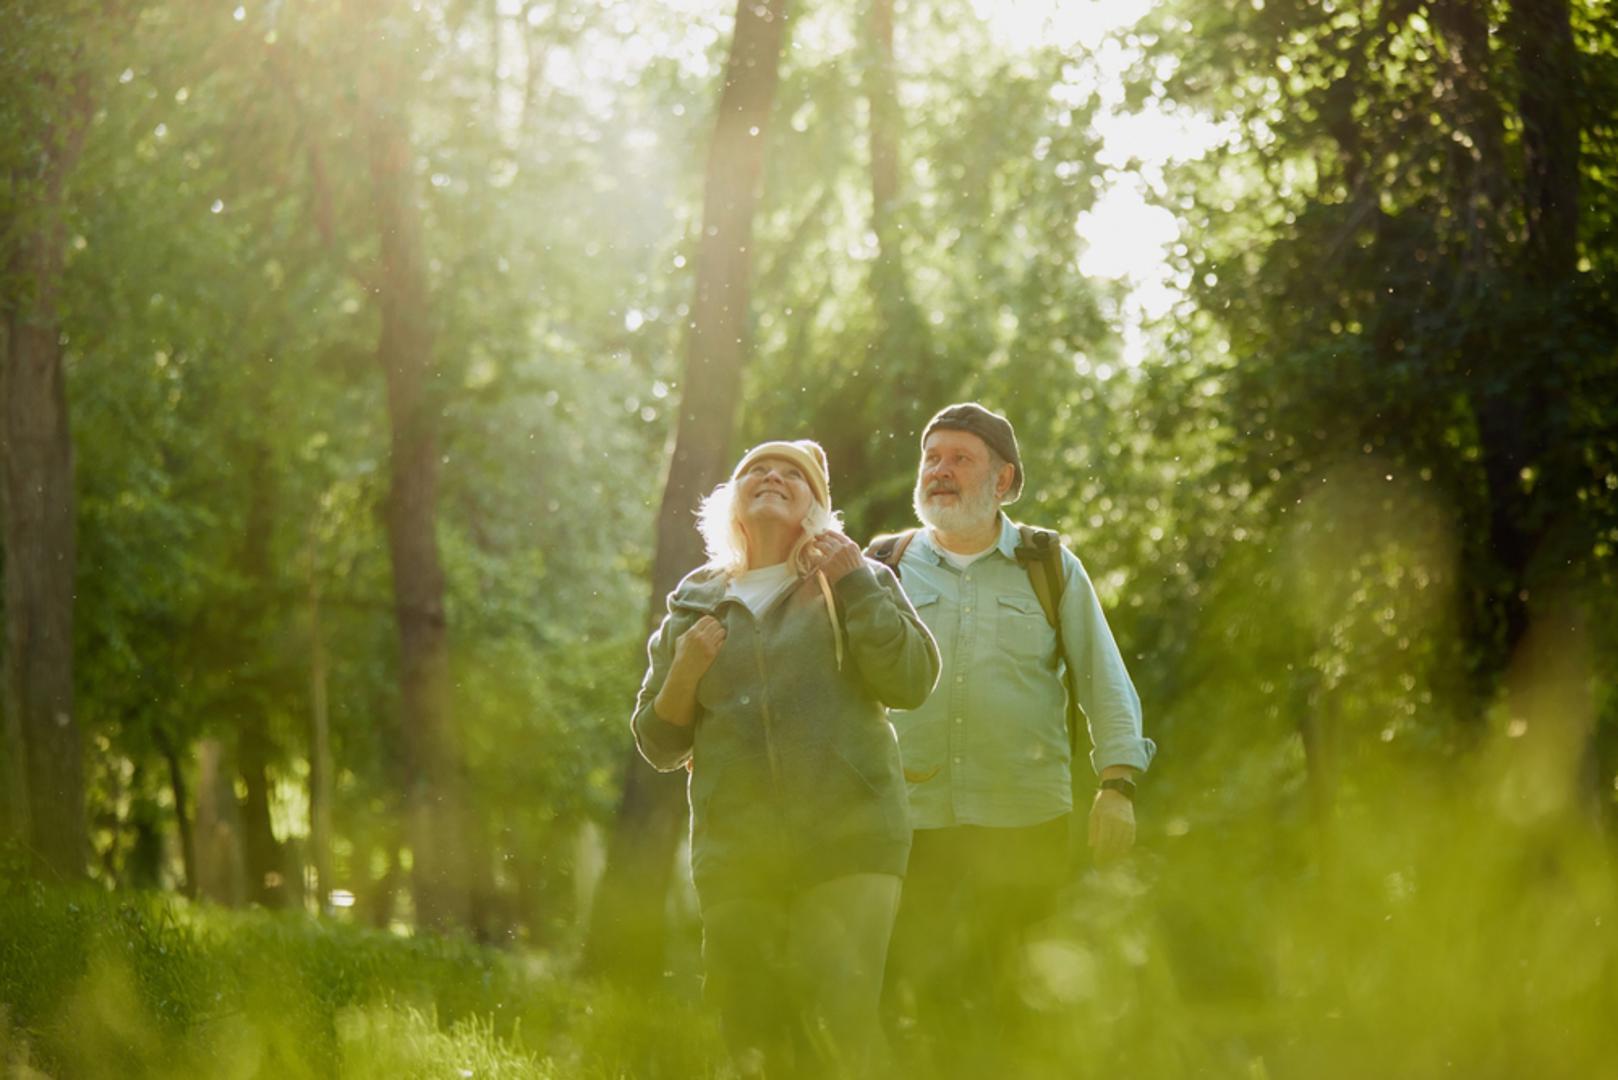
[887,814,1071,1070]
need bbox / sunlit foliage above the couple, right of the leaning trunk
[739,3,1116,538]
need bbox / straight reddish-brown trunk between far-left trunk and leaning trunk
[367,88,468,928]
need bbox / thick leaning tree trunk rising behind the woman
[584,0,788,980]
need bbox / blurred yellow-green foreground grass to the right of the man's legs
[964,769,1618,1078]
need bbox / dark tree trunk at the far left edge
[0,67,92,879]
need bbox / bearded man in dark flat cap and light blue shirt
[867,403,1155,1036]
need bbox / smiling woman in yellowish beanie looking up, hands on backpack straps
[633,440,938,1072]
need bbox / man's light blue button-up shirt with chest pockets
[892,513,1157,829]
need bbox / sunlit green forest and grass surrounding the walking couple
[0,0,1618,1075]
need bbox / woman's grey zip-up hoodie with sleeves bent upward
[631,559,938,905]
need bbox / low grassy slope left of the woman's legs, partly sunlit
[0,879,717,1080]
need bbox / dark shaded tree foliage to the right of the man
[1131,0,1618,819]
